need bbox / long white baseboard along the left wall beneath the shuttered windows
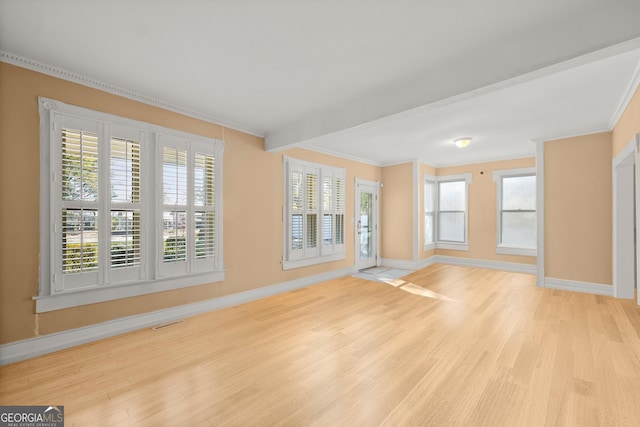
[0,267,357,366]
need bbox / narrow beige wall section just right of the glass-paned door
[380,163,413,261]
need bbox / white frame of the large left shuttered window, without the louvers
[33,97,225,313]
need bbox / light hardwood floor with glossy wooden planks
[0,265,640,426]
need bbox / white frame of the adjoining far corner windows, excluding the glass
[423,173,472,251]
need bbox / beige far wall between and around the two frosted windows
[436,157,536,264]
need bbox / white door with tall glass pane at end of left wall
[354,178,380,270]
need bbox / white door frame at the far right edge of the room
[612,134,640,304]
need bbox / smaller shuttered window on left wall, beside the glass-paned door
[283,157,346,270]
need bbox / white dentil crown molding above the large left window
[0,49,264,138]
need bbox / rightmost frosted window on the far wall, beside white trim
[493,168,536,256]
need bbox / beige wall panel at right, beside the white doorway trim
[544,132,613,285]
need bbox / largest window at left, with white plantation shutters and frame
[36,98,224,312]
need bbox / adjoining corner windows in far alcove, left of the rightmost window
[424,174,471,250]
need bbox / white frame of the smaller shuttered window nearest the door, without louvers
[282,156,346,270]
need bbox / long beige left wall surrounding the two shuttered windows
[0,63,382,343]
